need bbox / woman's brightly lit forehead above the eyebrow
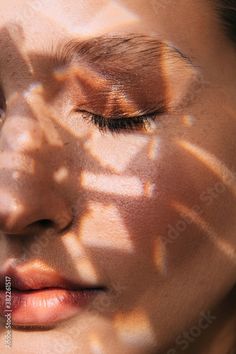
[0,0,221,50]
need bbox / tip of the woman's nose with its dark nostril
[0,180,73,235]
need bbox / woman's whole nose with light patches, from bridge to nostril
[0,101,72,235]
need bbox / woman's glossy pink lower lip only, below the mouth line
[0,288,102,327]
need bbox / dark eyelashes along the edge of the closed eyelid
[80,108,165,133]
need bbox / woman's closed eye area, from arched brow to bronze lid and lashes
[15,34,198,133]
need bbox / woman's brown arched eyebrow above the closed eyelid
[51,34,193,69]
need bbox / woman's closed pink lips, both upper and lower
[0,266,106,327]
